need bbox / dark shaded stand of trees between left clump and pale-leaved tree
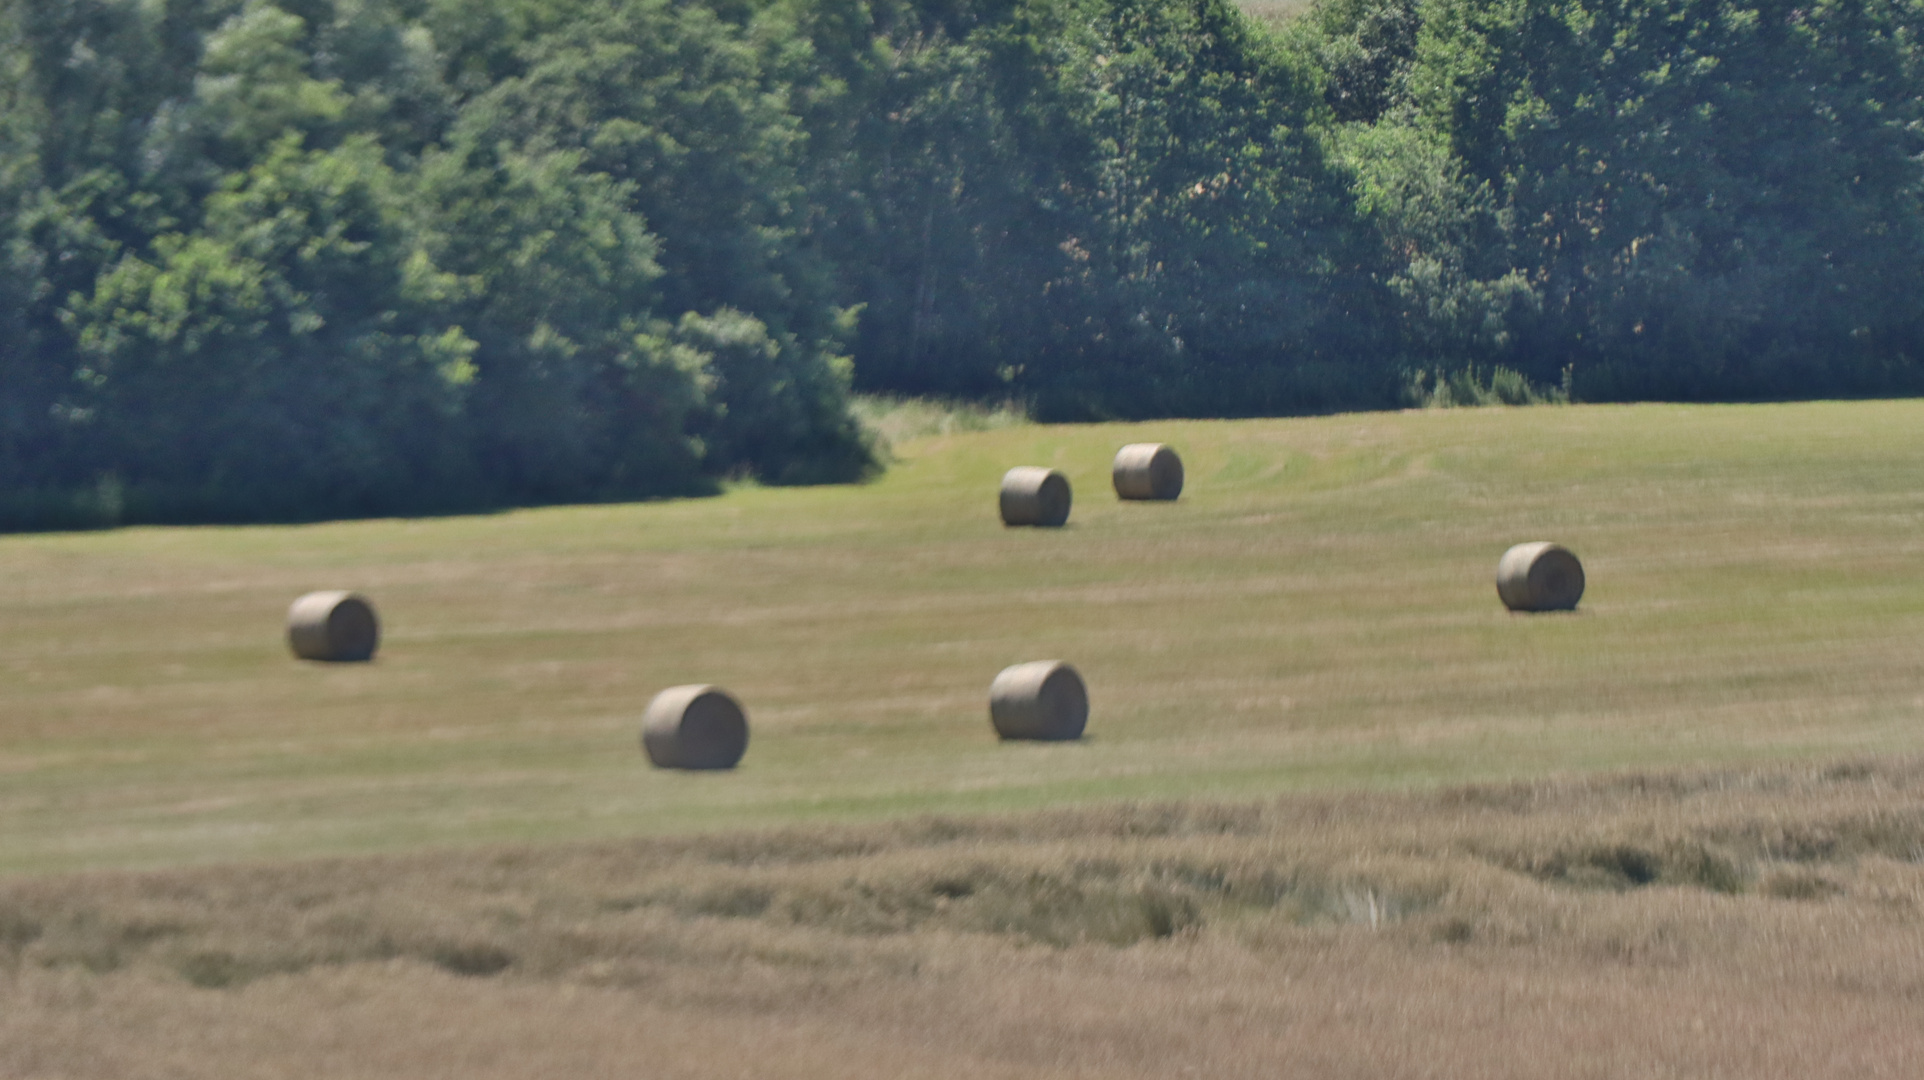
[810,0,1391,418]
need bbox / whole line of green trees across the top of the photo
[0,0,1924,527]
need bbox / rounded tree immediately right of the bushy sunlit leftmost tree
[419,134,706,501]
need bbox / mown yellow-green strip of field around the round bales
[0,400,1924,874]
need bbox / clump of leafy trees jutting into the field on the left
[0,0,868,524]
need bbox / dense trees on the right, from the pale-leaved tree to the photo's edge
[1297,0,1924,399]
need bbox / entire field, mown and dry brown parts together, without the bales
[0,402,1924,1076]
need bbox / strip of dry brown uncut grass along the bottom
[0,760,1924,1080]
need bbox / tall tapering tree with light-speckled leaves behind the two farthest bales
[1033,0,1389,416]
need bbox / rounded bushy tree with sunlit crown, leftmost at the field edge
[67,133,473,518]
